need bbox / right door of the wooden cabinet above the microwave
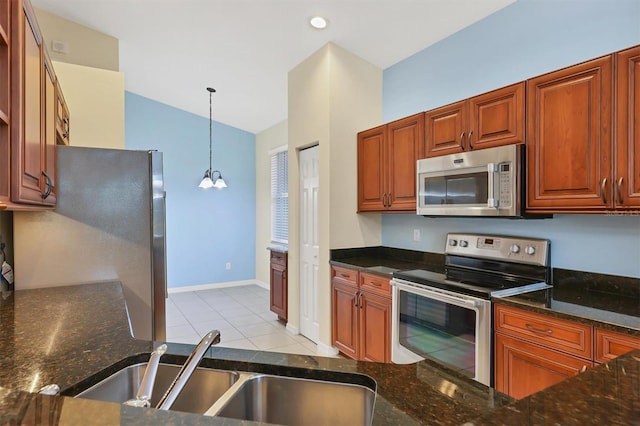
[467,82,525,149]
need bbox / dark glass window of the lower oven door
[398,291,477,377]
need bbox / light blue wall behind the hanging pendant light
[125,92,256,288]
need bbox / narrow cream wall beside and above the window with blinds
[256,120,289,285]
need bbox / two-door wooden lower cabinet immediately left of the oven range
[331,267,391,362]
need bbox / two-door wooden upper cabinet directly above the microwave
[425,82,525,157]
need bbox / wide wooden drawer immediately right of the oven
[495,305,593,359]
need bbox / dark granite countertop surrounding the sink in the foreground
[0,256,640,425]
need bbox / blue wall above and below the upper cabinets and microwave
[382,0,640,277]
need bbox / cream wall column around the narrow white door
[288,43,382,347]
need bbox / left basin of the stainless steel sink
[76,363,239,414]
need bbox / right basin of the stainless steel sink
[206,374,376,426]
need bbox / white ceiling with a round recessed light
[32,0,515,133]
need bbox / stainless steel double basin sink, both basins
[75,363,376,425]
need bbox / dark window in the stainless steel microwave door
[422,171,489,206]
